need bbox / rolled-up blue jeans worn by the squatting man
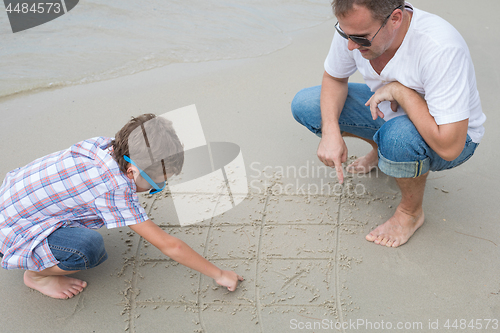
[292,83,478,178]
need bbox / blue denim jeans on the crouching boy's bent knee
[0,227,108,271]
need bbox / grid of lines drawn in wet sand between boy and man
[115,169,374,332]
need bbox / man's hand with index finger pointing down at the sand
[318,133,347,184]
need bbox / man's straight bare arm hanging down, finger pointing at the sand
[317,72,349,184]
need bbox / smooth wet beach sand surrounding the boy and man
[0,0,500,333]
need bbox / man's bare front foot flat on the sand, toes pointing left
[366,207,424,247]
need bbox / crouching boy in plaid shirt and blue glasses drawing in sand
[0,114,243,299]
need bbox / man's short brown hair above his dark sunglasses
[332,0,405,22]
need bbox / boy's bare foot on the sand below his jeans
[24,271,87,299]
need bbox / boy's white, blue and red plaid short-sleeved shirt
[0,137,148,271]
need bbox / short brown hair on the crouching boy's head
[111,113,184,177]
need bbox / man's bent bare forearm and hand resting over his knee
[366,82,469,161]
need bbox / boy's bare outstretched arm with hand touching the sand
[129,220,243,291]
